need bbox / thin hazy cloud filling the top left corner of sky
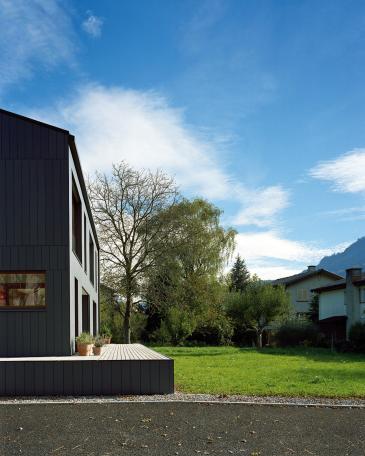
[0,0,74,90]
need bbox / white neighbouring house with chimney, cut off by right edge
[312,268,365,339]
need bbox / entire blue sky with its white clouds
[0,0,365,278]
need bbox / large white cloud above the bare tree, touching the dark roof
[26,85,286,225]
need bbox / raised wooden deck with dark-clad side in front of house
[0,344,174,396]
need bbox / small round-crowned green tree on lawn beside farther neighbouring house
[228,279,291,348]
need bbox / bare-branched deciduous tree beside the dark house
[88,162,179,343]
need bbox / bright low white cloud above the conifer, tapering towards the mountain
[237,230,350,279]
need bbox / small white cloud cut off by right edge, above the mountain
[309,149,365,193]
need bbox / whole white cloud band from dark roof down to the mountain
[23,84,347,278]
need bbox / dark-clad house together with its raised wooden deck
[0,109,174,395]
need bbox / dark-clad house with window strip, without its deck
[0,110,99,356]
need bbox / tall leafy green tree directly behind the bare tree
[145,199,235,339]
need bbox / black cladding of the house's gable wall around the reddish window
[0,110,71,357]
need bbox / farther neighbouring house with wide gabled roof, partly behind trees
[271,266,342,318]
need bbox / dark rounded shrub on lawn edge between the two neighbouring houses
[275,321,323,347]
